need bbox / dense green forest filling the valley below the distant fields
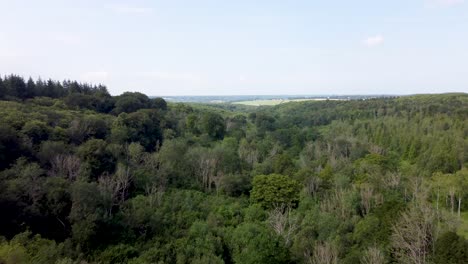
[0,75,468,264]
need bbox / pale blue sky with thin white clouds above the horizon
[0,0,468,96]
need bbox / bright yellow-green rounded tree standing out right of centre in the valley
[250,174,301,208]
